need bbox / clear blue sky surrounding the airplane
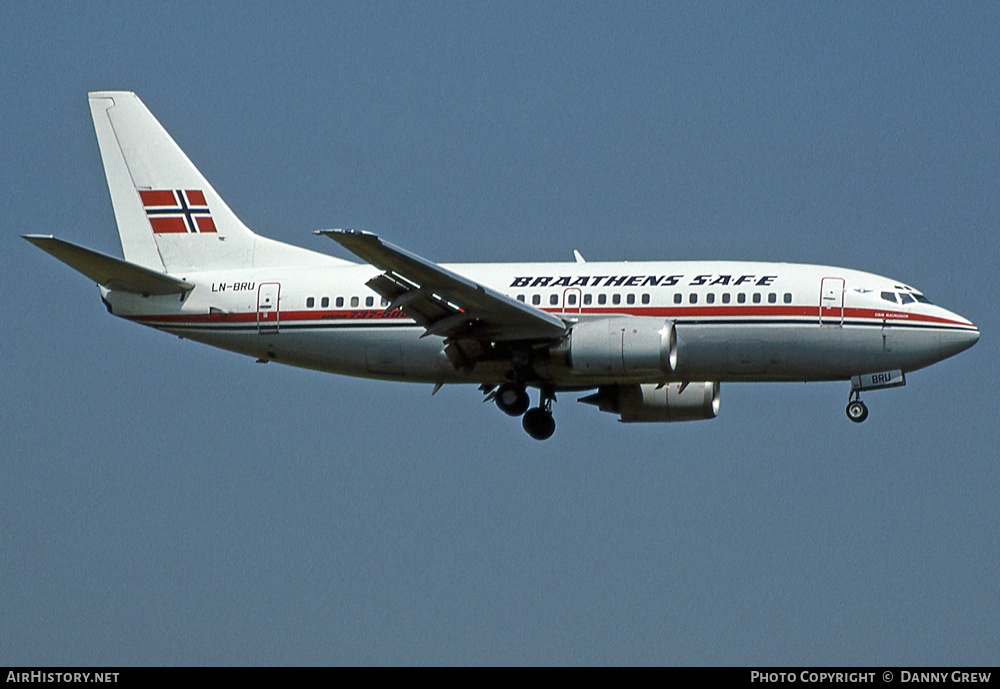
[0,2,1000,665]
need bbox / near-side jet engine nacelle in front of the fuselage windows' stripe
[568,316,677,375]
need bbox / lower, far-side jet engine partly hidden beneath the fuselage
[579,381,719,423]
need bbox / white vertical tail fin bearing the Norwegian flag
[90,91,346,273]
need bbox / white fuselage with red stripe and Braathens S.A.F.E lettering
[102,261,979,389]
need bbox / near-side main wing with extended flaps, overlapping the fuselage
[316,230,568,342]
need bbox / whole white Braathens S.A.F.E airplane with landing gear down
[23,91,979,440]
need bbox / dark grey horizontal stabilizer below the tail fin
[21,234,194,295]
